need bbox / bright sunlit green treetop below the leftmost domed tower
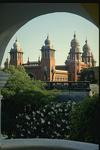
[1,66,35,98]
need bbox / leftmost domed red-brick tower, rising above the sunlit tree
[10,39,23,66]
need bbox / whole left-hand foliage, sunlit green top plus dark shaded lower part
[1,66,57,138]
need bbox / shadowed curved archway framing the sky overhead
[0,3,99,65]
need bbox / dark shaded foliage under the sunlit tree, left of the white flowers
[1,91,56,138]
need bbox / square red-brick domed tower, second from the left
[41,36,55,81]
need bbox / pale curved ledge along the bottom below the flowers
[2,138,99,150]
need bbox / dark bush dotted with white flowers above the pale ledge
[14,101,74,139]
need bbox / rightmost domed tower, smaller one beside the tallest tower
[82,39,96,67]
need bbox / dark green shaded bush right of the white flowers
[70,95,100,143]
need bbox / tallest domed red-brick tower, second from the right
[65,33,82,81]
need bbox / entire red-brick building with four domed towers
[5,34,96,81]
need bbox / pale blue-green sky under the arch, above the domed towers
[2,12,99,66]
